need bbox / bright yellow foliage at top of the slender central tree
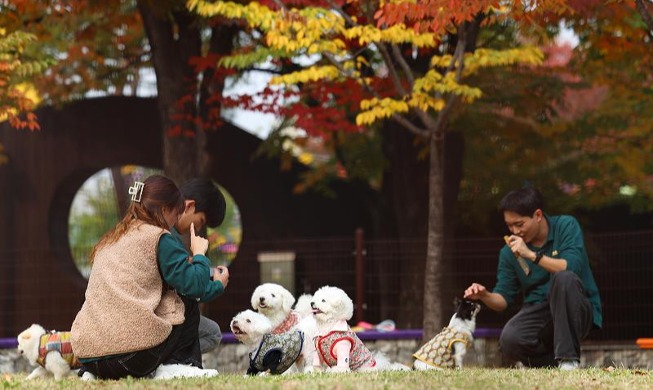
[188,0,542,136]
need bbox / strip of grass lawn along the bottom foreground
[0,368,653,390]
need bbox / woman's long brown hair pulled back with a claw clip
[89,175,184,262]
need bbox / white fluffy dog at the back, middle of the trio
[251,283,309,334]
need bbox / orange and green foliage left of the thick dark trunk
[1,0,150,105]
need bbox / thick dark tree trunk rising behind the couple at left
[138,0,206,185]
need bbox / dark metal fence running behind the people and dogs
[0,231,653,340]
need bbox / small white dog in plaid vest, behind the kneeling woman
[18,324,81,380]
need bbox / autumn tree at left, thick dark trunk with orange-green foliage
[0,0,237,183]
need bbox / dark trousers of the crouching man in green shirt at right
[499,271,593,367]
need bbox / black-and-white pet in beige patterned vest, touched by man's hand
[413,297,481,370]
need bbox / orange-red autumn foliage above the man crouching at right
[460,0,653,215]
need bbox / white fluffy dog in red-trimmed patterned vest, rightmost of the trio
[311,286,409,373]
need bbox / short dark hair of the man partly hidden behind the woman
[179,178,227,228]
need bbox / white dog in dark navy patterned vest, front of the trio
[229,310,314,375]
